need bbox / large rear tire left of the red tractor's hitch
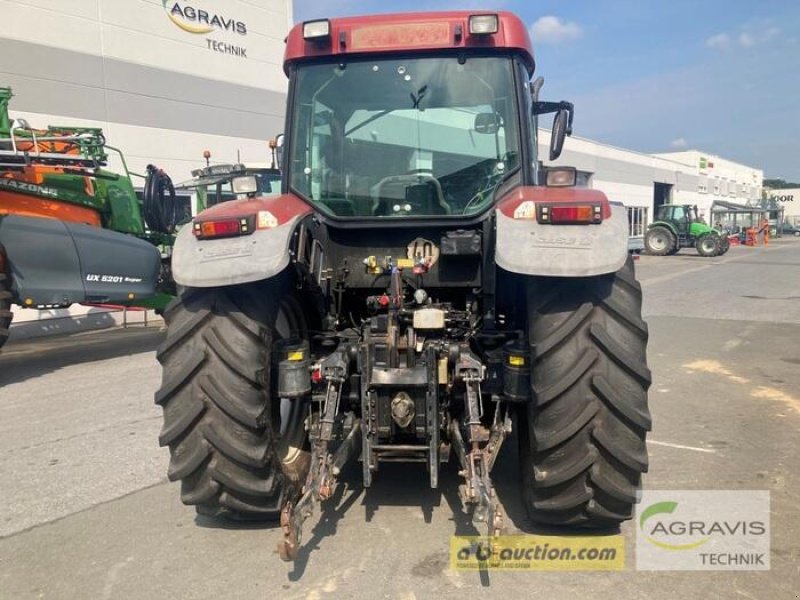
[156,284,310,519]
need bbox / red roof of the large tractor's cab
[283,11,535,75]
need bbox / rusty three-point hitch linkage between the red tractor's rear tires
[278,269,511,561]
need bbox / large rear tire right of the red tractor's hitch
[520,258,651,528]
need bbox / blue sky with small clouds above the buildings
[294,0,800,181]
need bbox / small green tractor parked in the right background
[644,204,730,257]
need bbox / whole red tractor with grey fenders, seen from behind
[156,11,651,559]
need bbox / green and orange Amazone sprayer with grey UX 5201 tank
[0,87,177,345]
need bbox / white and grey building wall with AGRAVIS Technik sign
[0,0,293,178]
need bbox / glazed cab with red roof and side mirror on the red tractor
[282,13,572,224]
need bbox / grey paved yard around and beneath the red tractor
[0,240,800,600]
